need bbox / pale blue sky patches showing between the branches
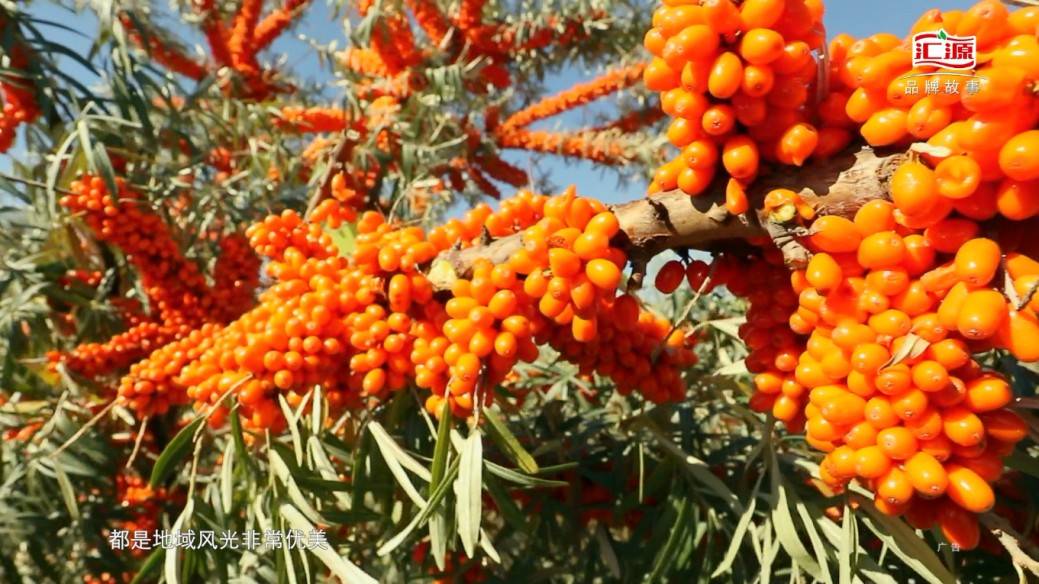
[12,0,974,203]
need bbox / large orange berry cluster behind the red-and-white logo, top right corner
[830,0,1039,228]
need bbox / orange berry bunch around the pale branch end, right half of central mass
[421,189,694,413]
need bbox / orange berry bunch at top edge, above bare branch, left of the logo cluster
[644,0,835,207]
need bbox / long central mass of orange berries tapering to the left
[107,183,695,429]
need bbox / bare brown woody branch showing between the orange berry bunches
[429,149,907,290]
